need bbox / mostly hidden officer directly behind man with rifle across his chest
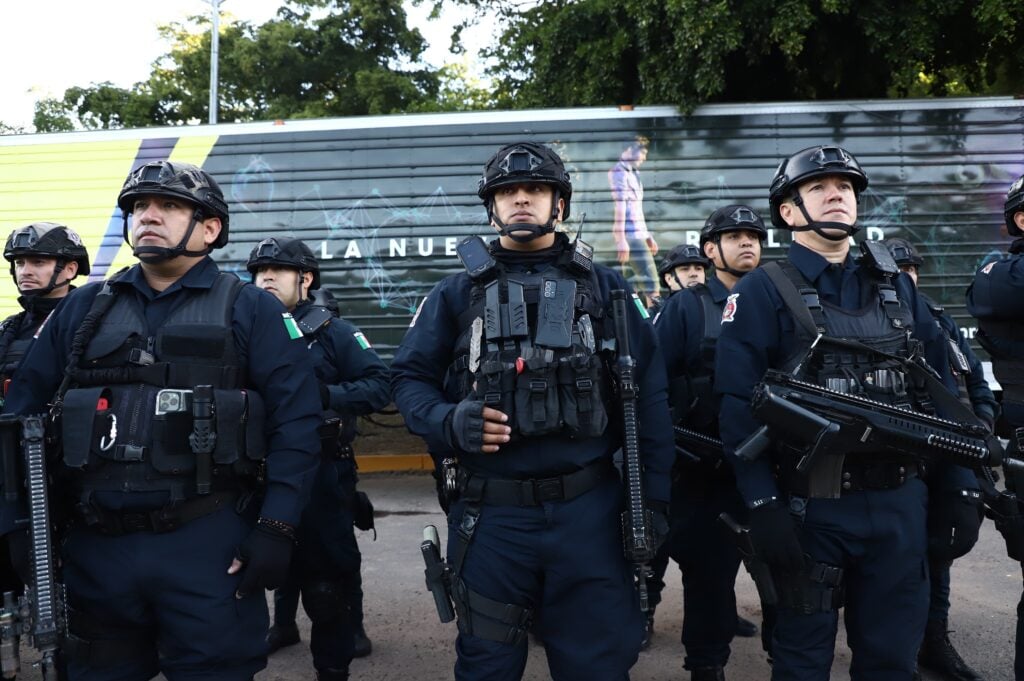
[885,239,999,681]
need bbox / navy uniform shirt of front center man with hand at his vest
[391,249,675,502]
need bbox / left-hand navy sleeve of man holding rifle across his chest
[715,270,787,505]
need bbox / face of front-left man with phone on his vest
[132,195,221,251]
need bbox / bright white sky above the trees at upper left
[0,0,481,130]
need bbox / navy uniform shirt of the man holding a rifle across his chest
[715,243,977,504]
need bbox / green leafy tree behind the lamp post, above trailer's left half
[35,0,439,131]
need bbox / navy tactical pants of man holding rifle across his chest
[771,478,929,681]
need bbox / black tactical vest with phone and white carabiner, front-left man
[61,273,266,502]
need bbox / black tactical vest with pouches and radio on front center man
[445,260,611,438]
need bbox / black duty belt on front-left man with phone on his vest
[75,491,240,537]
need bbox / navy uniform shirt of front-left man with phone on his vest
[4,257,321,525]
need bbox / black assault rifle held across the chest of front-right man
[736,370,1002,497]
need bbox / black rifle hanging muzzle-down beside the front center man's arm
[611,289,656,612]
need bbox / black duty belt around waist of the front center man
[459,459,615,506]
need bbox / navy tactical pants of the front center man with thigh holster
[447,480,643,681]
